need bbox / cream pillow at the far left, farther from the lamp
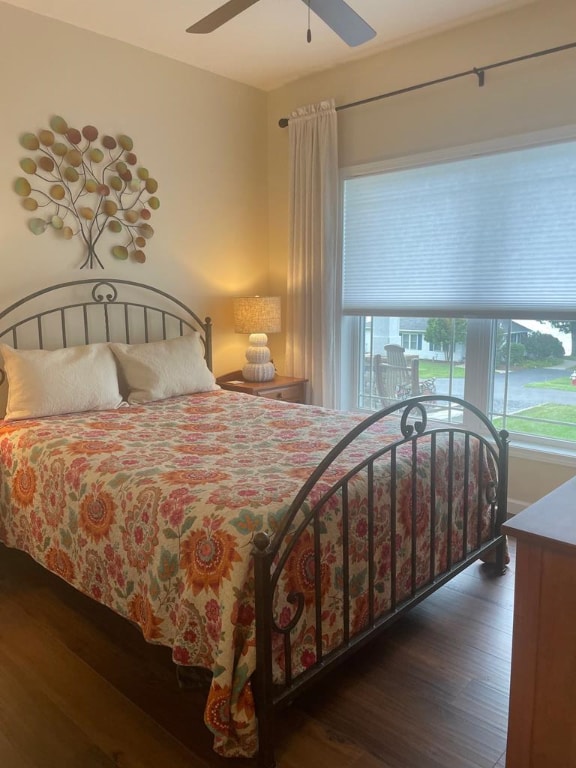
[0,344,122,421]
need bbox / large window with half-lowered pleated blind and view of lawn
[342,131,576,451]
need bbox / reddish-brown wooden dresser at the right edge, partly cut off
[504,478,576,768]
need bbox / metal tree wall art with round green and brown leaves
[14,116,160,269]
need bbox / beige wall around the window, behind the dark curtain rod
[268,0,576,505]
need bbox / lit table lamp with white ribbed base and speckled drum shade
[234,296,280,381]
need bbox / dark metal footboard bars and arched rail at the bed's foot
[254,395,508,768]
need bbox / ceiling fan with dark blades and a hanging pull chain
[186,0,376,46]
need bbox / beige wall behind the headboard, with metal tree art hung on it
[0,3,268,374]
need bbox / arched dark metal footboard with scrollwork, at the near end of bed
[253,395,508,768]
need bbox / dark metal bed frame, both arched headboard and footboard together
[0,279,508,768]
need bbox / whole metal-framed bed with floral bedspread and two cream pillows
[0,279,508,768]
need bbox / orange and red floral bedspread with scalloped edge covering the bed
[0,391,496,756]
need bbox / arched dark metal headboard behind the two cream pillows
[0,279,212,383]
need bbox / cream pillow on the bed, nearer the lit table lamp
[110,332,220,403]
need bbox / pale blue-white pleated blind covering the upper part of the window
[342,141,576,319]
